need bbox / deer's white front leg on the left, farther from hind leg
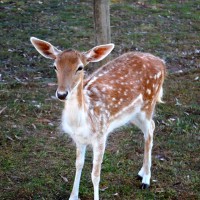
[69,145,86,200]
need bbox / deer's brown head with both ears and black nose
[31,37,114,100]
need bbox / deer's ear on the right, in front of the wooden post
[84,44,115,62]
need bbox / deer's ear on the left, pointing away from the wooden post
[30,37,61,59]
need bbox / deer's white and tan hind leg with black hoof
[132,113,155,189]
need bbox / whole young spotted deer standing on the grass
[30,37,166,200]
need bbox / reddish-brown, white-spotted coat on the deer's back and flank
[84,52,165,119]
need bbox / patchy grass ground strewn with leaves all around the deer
[0,0,200,200]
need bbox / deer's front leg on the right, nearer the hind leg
[92,140,105,200]
